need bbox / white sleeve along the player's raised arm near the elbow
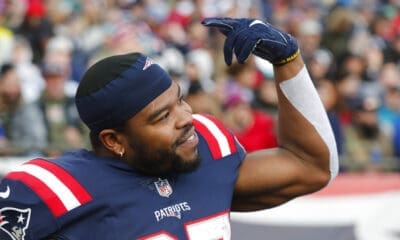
[279,66,339,181]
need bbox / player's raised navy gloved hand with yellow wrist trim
[202,18,299,65]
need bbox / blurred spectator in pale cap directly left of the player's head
[40,62,86,156]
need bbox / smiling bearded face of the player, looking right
[120,83,200,175]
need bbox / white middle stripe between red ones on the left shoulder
[15,164,81,211]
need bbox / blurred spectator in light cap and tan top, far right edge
[341,96,398,172]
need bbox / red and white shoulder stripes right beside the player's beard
[193,114,237,159]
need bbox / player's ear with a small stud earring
[99,129,125,156]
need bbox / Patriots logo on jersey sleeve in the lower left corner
[0,207,31,240]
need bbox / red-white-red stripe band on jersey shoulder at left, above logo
[5,159,92,217]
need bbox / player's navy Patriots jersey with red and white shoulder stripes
[0,115,245,240]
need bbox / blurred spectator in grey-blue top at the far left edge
[0,64,47,155]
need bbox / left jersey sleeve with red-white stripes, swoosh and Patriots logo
[0,158,92,239]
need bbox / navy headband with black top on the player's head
[75,53,172,132]
